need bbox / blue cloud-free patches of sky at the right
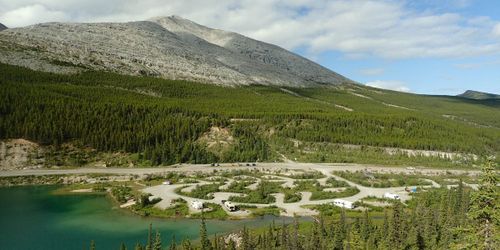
[310,0,500,95]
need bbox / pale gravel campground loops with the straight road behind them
[0,162,480,217]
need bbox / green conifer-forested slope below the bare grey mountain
[0,64,500,165]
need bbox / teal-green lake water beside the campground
[0,186,292,250]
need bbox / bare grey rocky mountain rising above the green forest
[0,16,352,87]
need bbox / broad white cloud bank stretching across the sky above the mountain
[0,0,500,58]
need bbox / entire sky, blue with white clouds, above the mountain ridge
[0,0,500,95]
